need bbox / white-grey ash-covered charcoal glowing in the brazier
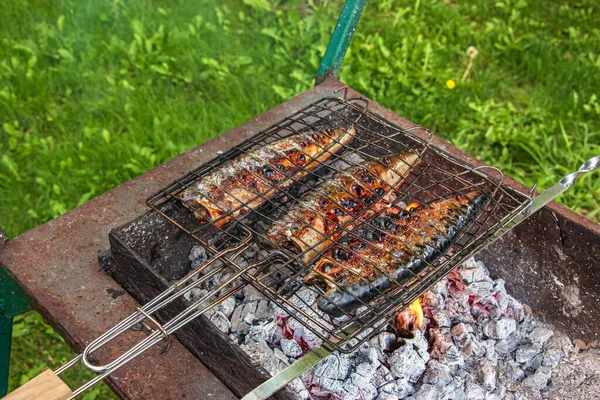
[190,244,584,400]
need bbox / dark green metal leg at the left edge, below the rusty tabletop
[0,266,29,397]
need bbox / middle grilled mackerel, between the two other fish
[267,153,419,264]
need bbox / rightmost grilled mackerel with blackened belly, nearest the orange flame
[304,192,487,317]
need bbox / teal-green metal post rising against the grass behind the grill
[316,0,367,85]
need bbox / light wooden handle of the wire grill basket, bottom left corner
[2,369,71,400]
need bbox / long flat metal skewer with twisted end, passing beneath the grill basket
[242,156,600,400]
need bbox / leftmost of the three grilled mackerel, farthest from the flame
[177,127,356,227]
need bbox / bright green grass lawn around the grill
[0,0,600,400]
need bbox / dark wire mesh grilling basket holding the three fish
[147,98,531,352]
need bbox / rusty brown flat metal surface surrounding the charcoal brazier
[0,79,600,399]
